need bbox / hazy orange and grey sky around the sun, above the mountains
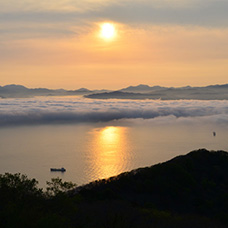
[0,0,228,89]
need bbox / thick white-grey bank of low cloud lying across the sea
[0,97,228,126]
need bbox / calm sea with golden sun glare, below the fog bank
[0,120,228,187]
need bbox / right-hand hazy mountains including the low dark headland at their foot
[86,84,228,100]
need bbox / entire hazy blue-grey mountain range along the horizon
[0,84,228,100]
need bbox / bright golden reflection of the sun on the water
[88,126,130,180]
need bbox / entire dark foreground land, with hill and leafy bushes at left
[0,149,228,228]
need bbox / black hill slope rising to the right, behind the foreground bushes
[80,149,228,216]
